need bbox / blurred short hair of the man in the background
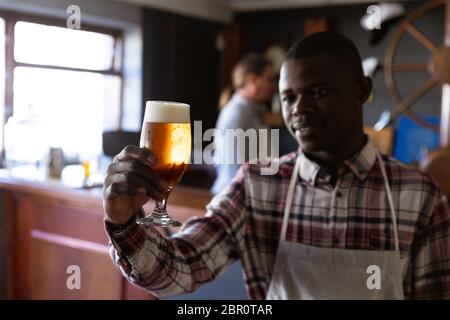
[232,53,272,90]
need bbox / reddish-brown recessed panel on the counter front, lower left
[29,230,122,299]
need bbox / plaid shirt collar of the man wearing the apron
[298,139,377,184]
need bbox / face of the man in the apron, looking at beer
[279,54,370,153]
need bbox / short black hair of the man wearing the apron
[285,32,364,77]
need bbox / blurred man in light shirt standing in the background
[212,53,276,194]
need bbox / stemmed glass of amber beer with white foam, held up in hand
[137,101,191,227]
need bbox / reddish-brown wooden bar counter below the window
[0,170,211,299]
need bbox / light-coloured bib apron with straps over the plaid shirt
[266,153,407,300]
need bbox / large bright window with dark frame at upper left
[0,12,122,164]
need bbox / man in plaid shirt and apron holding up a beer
[104,33,450,299]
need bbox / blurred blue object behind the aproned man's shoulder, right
[394,116,440,164]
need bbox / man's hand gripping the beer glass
[103,145,168,224]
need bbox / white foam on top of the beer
[144,101,191,123]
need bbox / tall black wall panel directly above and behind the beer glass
[142,9,221,130]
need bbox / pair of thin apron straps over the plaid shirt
[280,151,400,251]
